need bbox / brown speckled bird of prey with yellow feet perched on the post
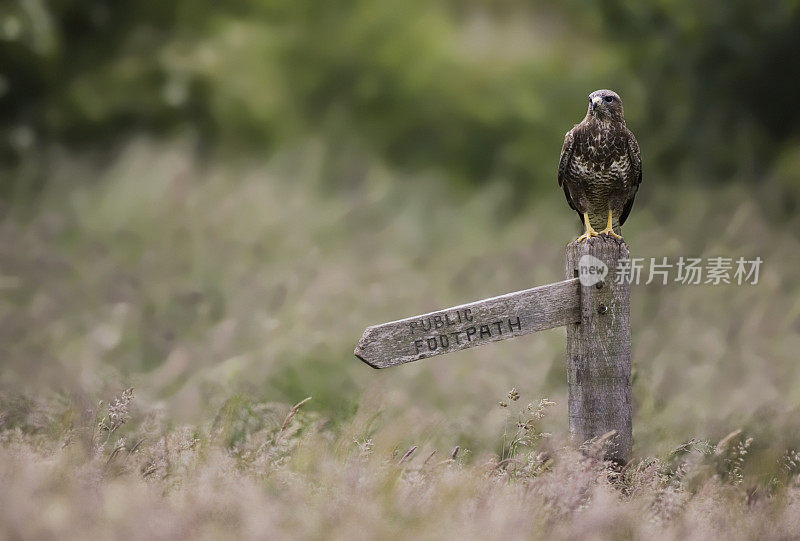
[558,90,642,242]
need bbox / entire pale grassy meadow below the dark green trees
[0,138,800,539]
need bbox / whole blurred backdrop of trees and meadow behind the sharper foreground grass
[0,0,800,460]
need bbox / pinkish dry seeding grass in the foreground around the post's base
[0,391,800,539]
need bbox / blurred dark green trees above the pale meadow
[0,0,800,190]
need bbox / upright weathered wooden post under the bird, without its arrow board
[567,236,633,464]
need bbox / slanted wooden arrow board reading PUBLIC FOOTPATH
[354,278,580,368]
